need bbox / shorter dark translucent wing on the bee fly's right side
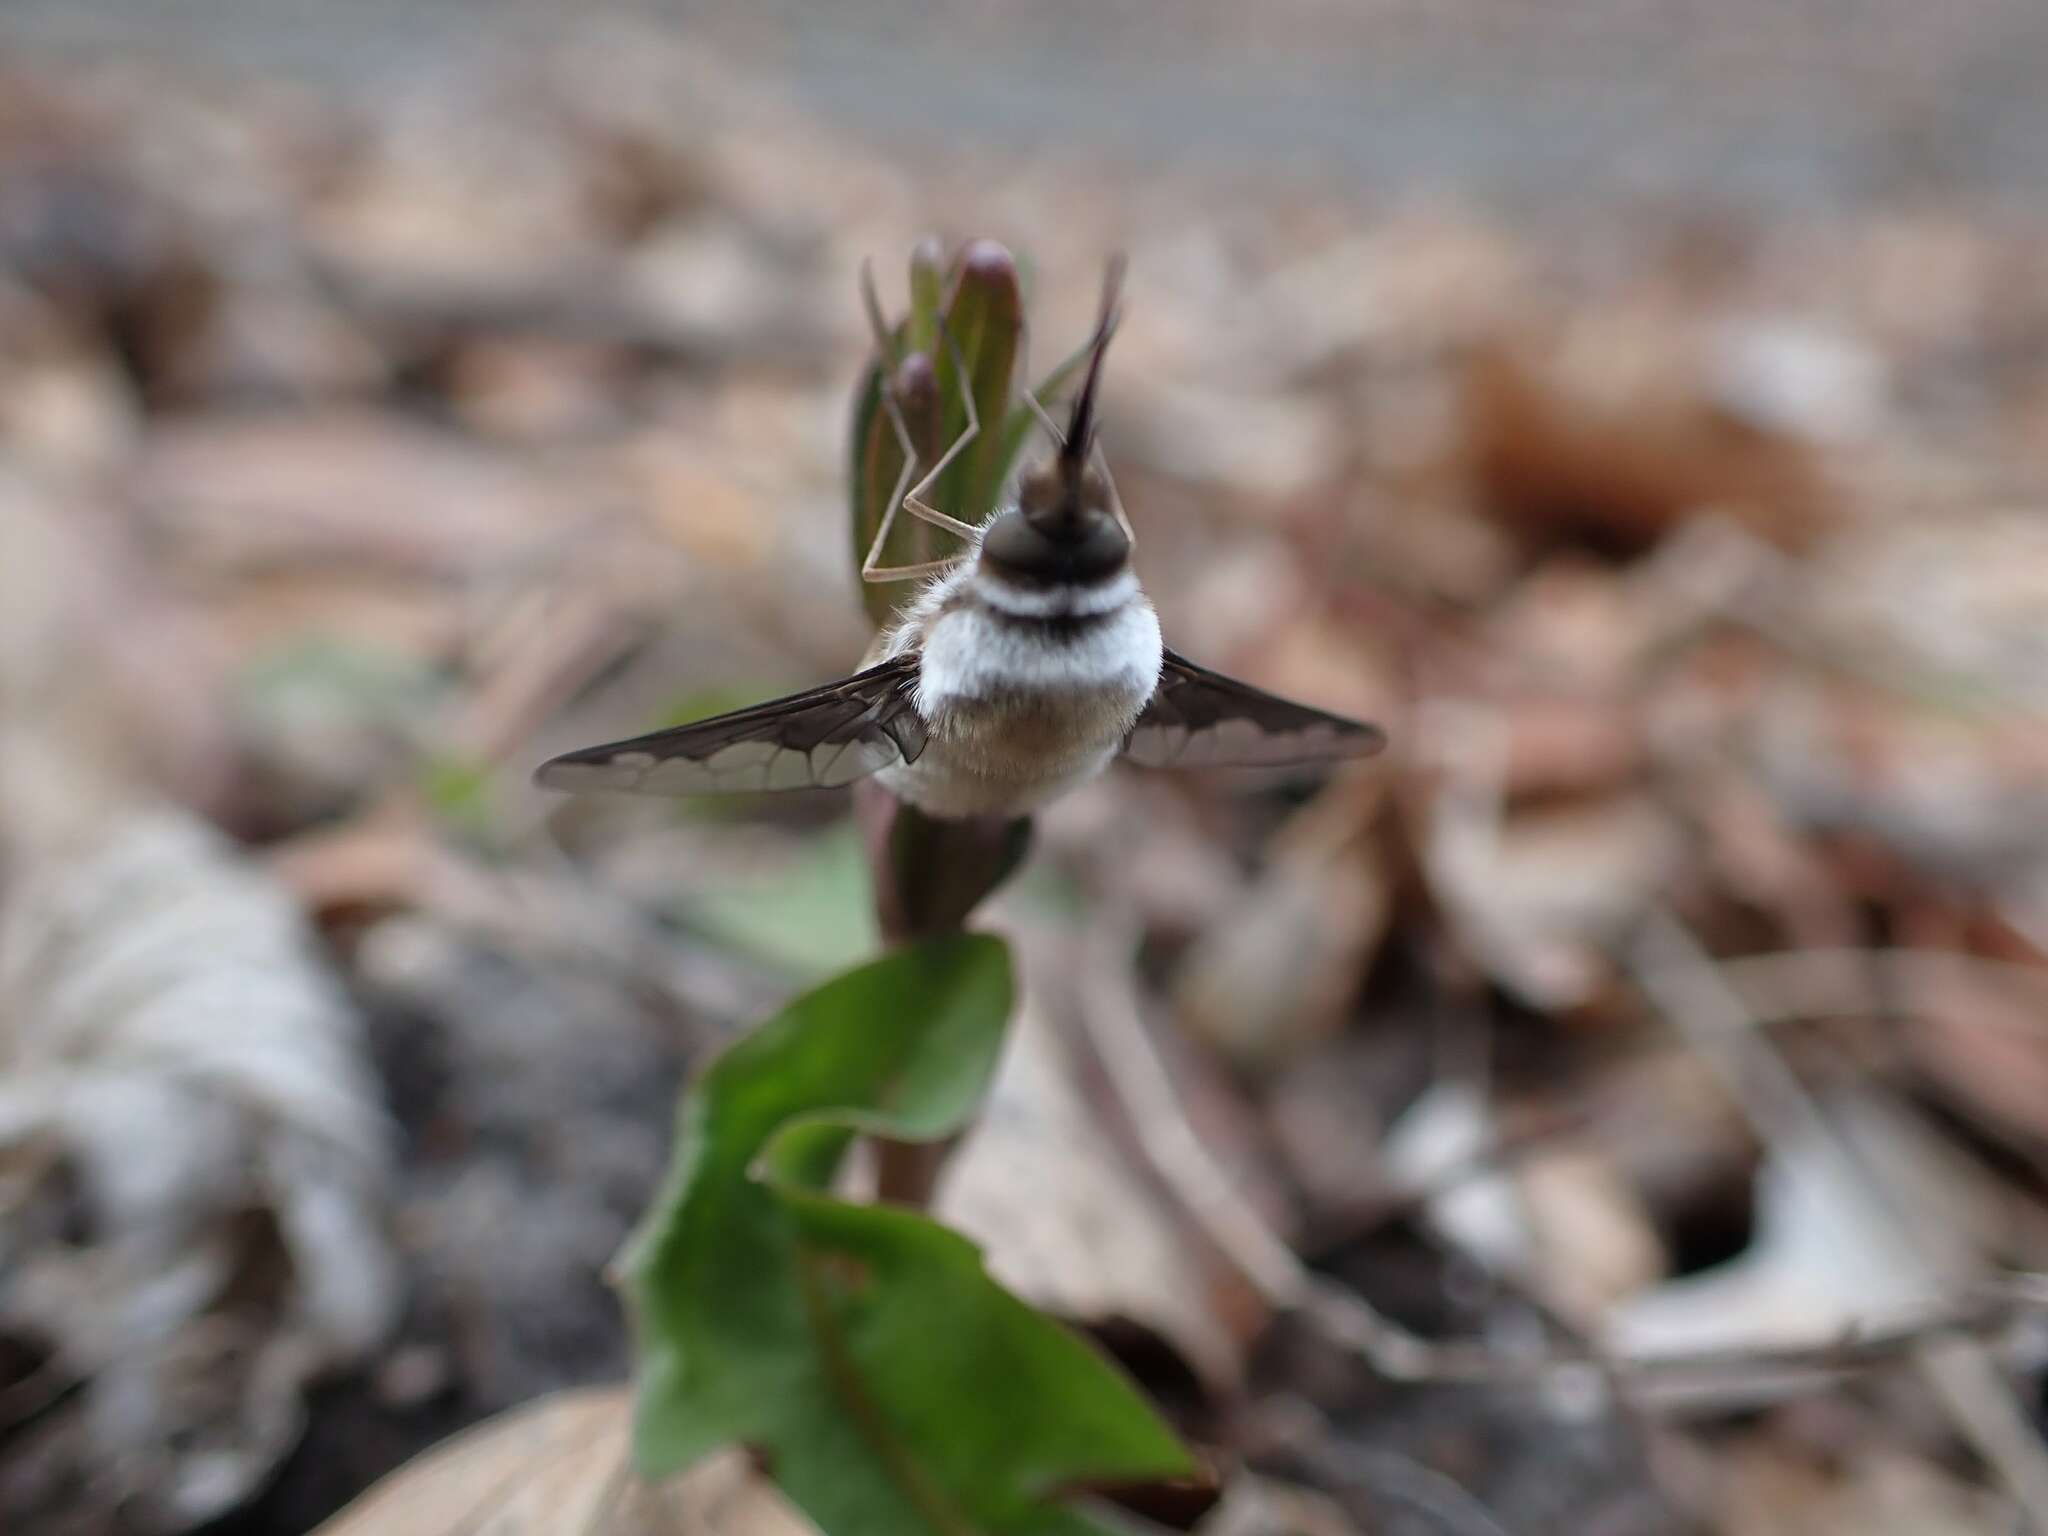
[1124,651,1386,768]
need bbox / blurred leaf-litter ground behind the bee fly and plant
[12,0,2048,1536]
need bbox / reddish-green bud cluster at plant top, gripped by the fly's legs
[848,240,1085,627]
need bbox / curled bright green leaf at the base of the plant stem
[627,934,1192,1536]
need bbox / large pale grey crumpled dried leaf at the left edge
[0,811,399,1532]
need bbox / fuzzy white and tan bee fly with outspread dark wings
[535,264,1386,817]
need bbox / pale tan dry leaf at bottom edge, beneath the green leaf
[313,1386,815,1536]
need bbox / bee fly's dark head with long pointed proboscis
[981,262,1130,586]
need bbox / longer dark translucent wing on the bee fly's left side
[532,651,926,795]
